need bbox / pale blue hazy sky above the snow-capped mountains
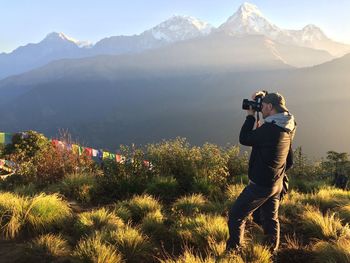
[0,0,350,53]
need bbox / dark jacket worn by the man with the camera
[239,115,293,187]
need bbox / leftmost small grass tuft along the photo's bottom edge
[29,234,70,261]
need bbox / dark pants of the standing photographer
[226,180,282,251]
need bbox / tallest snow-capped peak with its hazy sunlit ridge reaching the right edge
[217,3,350,56]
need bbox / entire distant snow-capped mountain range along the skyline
[0,3,350,79]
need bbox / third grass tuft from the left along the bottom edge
[107,225,152,262]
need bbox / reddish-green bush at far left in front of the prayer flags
[5,131,94,187]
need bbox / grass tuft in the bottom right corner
[313,238,350,263]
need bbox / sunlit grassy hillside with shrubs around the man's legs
[0,132,350,263]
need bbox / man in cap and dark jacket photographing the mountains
[226,92,296,252]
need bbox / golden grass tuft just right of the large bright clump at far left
[75,208,124,237]
